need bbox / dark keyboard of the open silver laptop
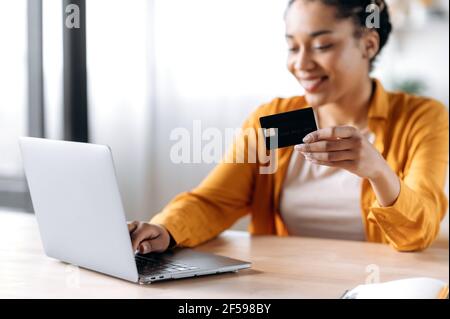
[135,256,199,276]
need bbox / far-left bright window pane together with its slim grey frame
[0,0,43,211]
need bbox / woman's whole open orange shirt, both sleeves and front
[151,80,449,251]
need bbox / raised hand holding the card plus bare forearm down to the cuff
[295,126,401,207]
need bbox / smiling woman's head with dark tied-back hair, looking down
[285,0,391,111]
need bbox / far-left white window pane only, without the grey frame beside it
[0,0,28,180]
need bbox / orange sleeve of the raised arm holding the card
[369,101,449,251]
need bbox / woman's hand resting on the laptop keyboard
[128,221,170,254]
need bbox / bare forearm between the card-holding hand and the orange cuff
[369,163,400,207]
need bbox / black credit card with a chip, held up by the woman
[259,107,317,150]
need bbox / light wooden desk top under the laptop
[0,213,449,298]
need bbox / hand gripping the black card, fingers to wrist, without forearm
[295,126,386,179]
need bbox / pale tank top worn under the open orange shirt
[280,131,375,241]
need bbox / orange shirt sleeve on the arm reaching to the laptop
[150,113,258,247]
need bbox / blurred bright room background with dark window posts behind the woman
[0,0,449,237]
